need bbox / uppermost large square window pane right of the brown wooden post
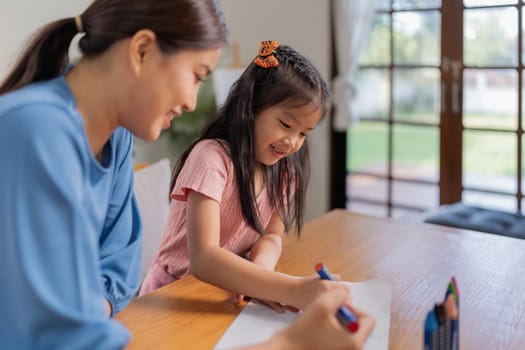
[463,7,518,67]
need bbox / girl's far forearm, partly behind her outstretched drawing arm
[250,212,284,270]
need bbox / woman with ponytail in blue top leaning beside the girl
[0,0,374,349]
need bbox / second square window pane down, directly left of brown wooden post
[393,68,440,124]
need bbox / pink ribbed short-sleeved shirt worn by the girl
[140,140,274,295]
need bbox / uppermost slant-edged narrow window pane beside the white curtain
[359,14,391,65]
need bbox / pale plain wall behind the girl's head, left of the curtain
[219,0,331,220]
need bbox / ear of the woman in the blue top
[128,29,158,75]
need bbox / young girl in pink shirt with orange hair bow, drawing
[140,41,344,309]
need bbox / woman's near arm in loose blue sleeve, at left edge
[0,106,129,349]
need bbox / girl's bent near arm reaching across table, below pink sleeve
[186,191,338,308]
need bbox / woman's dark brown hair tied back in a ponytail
[0,0,227,94]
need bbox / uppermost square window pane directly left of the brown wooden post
[393,11,441,66]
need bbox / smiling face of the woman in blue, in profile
[120,47,221,141]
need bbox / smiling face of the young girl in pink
[255,103,323,165]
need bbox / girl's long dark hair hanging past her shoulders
[170,45,329,234]
